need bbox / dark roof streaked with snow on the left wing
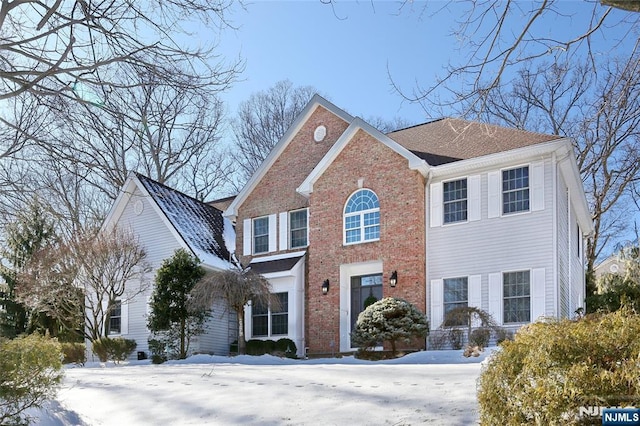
[136,173,235,269]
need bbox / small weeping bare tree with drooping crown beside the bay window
[191,262,272,354]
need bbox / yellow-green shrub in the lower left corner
[0,334,63,425]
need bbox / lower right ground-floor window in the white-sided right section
[502,271,531,324]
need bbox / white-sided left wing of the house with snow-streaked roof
[95,173,237,355]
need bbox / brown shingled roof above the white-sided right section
[387,118,560,161]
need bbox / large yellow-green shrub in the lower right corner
[478,309,640,425]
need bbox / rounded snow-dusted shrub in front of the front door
[351,297,429,355]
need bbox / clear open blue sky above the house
[218,0,632,127]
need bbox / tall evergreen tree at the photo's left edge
[0,198,56,338]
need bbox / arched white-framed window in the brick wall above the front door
[344,189,380,244]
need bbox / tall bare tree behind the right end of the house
[462,54,640,288]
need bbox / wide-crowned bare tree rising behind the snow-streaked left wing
[41,66,227,199]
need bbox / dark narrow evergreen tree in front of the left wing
[147,249,208,359]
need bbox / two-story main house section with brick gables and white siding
[224,96,592,355]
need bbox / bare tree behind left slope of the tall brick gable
[231,80,316,188]
